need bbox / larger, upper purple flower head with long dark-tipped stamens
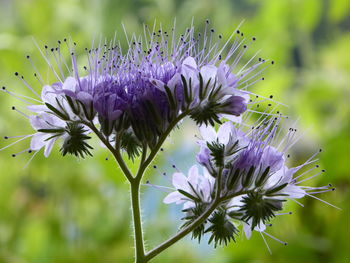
[3,22,267,157]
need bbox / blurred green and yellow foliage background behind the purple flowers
[0,0,350,263]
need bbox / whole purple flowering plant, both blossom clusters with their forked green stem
[0,21,334,262]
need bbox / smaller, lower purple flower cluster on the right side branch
[164,117,334,249]
